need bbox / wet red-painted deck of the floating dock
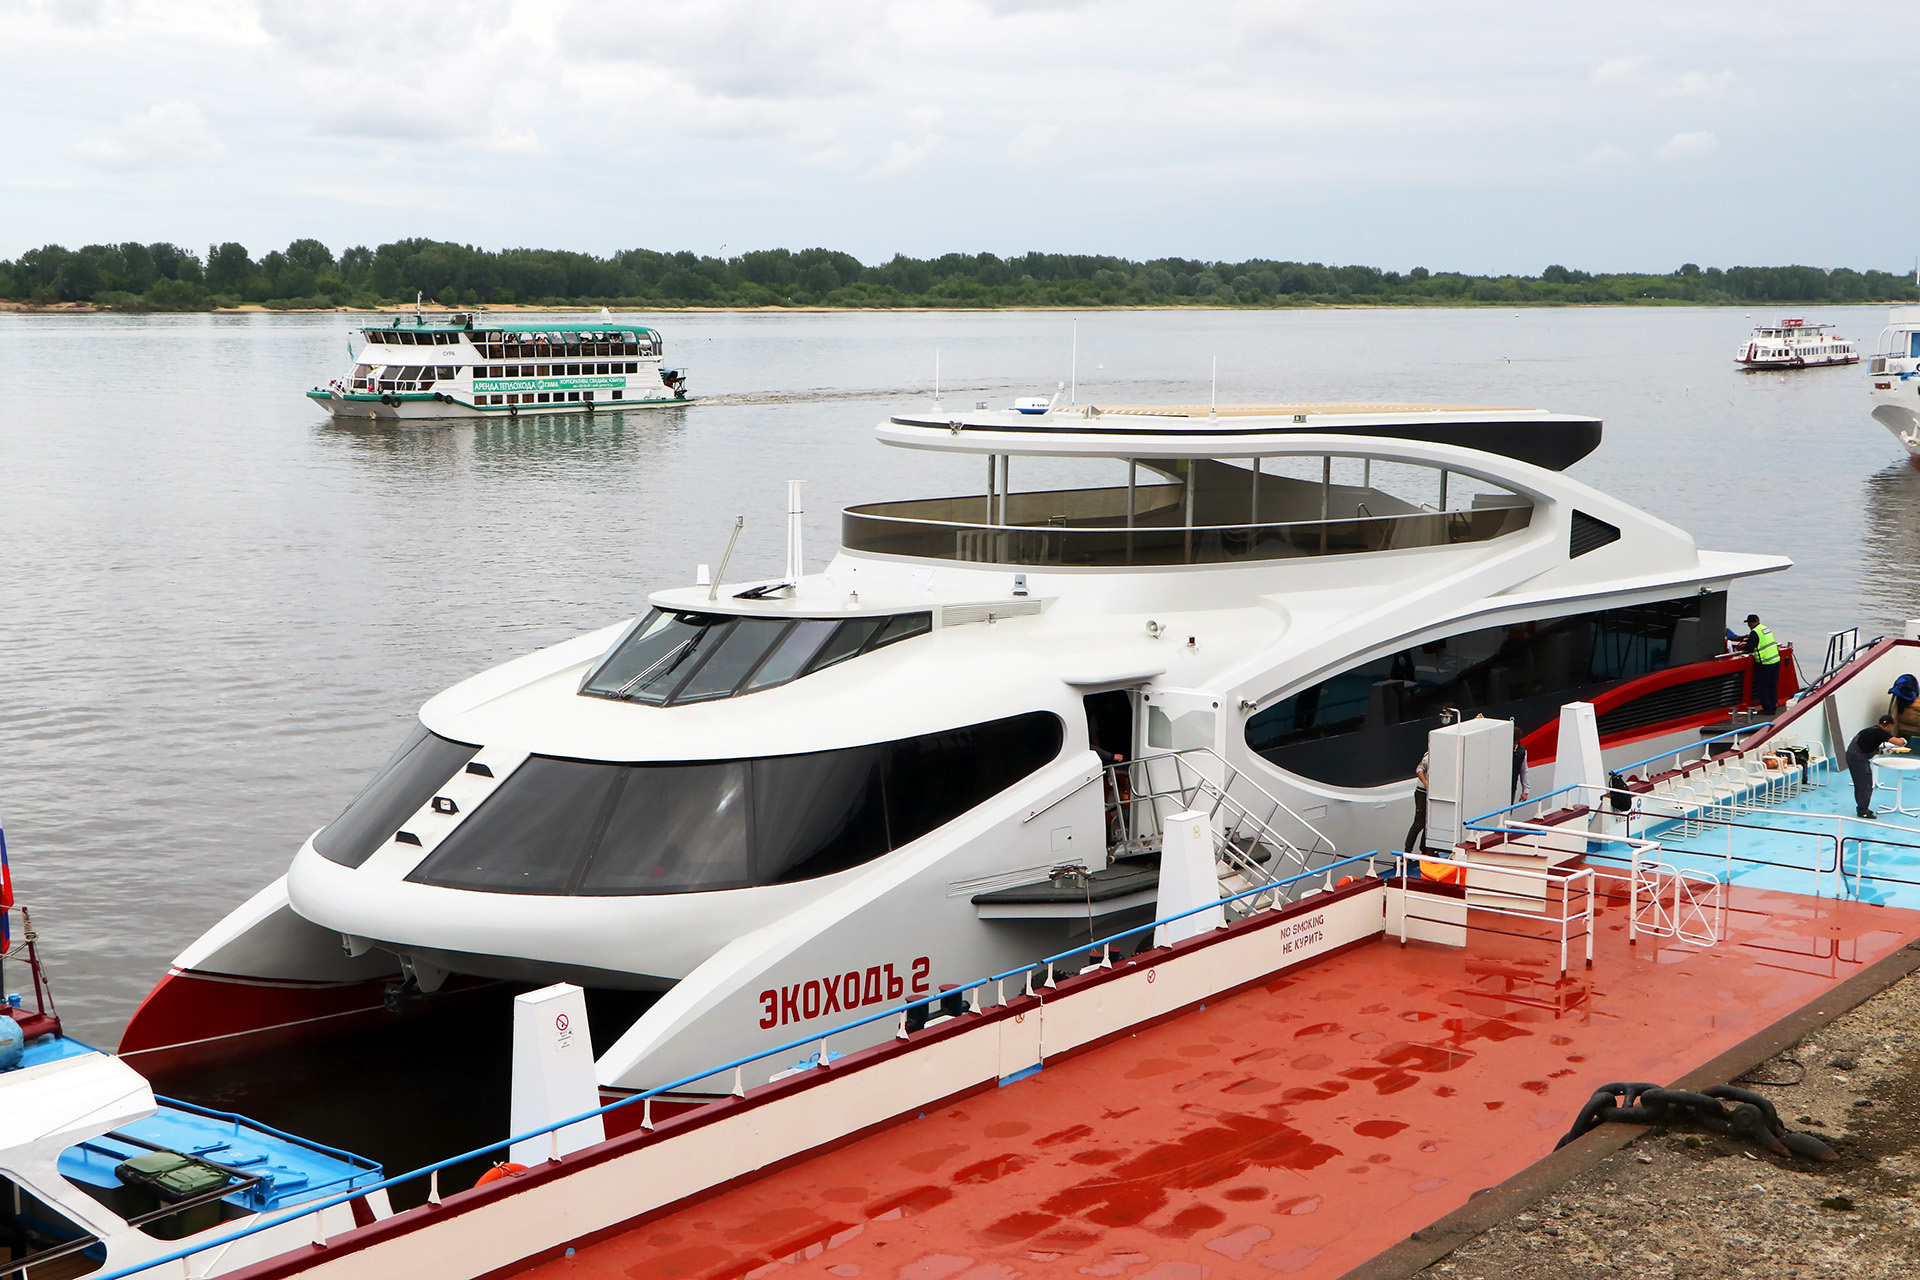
[524,889,1920,1280]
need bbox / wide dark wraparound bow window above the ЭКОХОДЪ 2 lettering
[408,712,1066,896]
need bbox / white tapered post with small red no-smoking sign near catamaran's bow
[507,983,607,1167]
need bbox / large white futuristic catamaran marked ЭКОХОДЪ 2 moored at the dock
[121,405,1793,1088]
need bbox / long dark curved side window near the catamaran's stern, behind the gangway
[1246,595,1726,787]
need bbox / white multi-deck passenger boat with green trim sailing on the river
[307,313,687,418]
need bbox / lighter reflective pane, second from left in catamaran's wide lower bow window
[576,760,753,894]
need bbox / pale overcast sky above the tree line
[0,0,1920,274]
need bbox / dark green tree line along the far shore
[0,240,1914,311]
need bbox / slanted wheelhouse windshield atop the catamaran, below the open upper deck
[580,608,933,706]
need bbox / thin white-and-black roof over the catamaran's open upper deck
[877,403,1601,470]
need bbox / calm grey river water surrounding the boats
[0,307,1920,1044]
